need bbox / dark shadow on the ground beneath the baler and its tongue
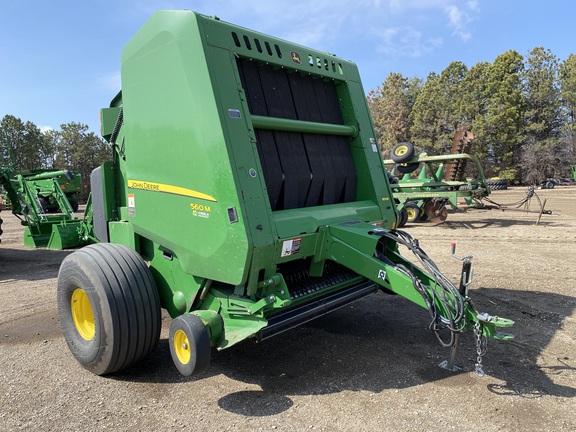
[113,288,576,416]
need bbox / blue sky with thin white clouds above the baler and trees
[0,0,576,133]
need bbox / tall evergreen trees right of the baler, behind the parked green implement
[367,47,576,184]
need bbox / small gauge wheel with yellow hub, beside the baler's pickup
[168,314,212,376]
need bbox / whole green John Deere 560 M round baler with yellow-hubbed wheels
[58,11,512,375]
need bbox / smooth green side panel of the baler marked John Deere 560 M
[122,12,250,285]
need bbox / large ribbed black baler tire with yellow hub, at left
[57,243,162,375]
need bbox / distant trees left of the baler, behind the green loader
[0,115,110,200]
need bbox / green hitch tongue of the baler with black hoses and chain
[315,222,514,374]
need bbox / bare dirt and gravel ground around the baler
[0,187,576,432]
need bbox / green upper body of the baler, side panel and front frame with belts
[119,11,396,291]
